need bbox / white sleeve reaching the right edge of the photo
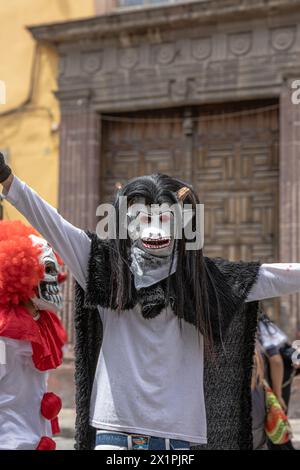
[246,263,300,302]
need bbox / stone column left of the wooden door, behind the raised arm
[57,90,100,344]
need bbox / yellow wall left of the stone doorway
[0,0,94,219]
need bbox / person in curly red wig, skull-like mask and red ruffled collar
[0,221,66,450]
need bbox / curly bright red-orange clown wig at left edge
[0,221,45,305]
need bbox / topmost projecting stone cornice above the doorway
[28,0,299,45]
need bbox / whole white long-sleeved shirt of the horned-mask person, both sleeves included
[6,177,300,443]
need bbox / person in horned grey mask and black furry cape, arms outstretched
[0,151,300,450]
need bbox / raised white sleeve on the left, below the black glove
[4,176,91,288]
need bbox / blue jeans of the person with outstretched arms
[95,431,190,450]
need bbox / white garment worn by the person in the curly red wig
[0,336,52,450]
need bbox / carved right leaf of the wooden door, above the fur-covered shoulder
[193,103,279,262]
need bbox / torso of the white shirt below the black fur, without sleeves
[90,306,206,443]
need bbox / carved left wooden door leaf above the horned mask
[100,111,185,202]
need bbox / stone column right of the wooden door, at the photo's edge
[279,78,300,339]
